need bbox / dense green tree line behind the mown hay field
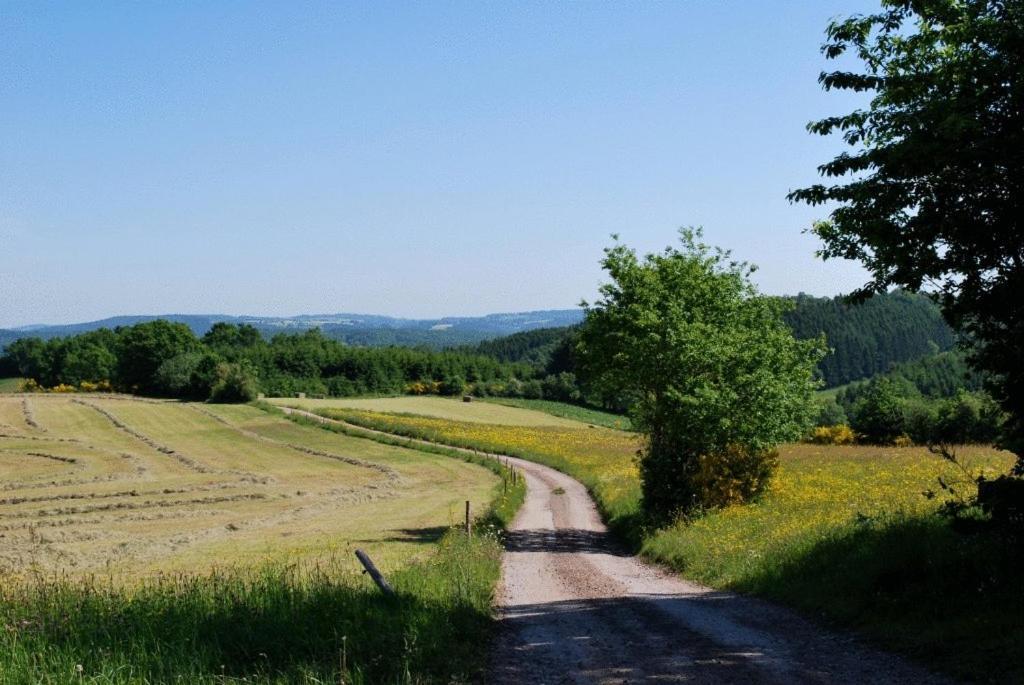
[0,319,540,401]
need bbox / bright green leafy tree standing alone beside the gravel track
[578,229,824,521]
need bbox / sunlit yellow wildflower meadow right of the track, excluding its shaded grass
[315,410,1013,587]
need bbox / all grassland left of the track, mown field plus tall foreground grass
[0,395,522,684]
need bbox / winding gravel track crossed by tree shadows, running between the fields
[276,410,950,685]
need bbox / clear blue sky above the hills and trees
[0,0,877,327]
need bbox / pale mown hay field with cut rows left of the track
[0,394,498,576]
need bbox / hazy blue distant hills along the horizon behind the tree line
[0,309,583,349]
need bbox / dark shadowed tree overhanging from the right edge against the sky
[790,0,1024,473]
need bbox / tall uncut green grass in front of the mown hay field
[0,531,501,685]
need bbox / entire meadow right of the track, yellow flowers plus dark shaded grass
[311,397,1024,682]
